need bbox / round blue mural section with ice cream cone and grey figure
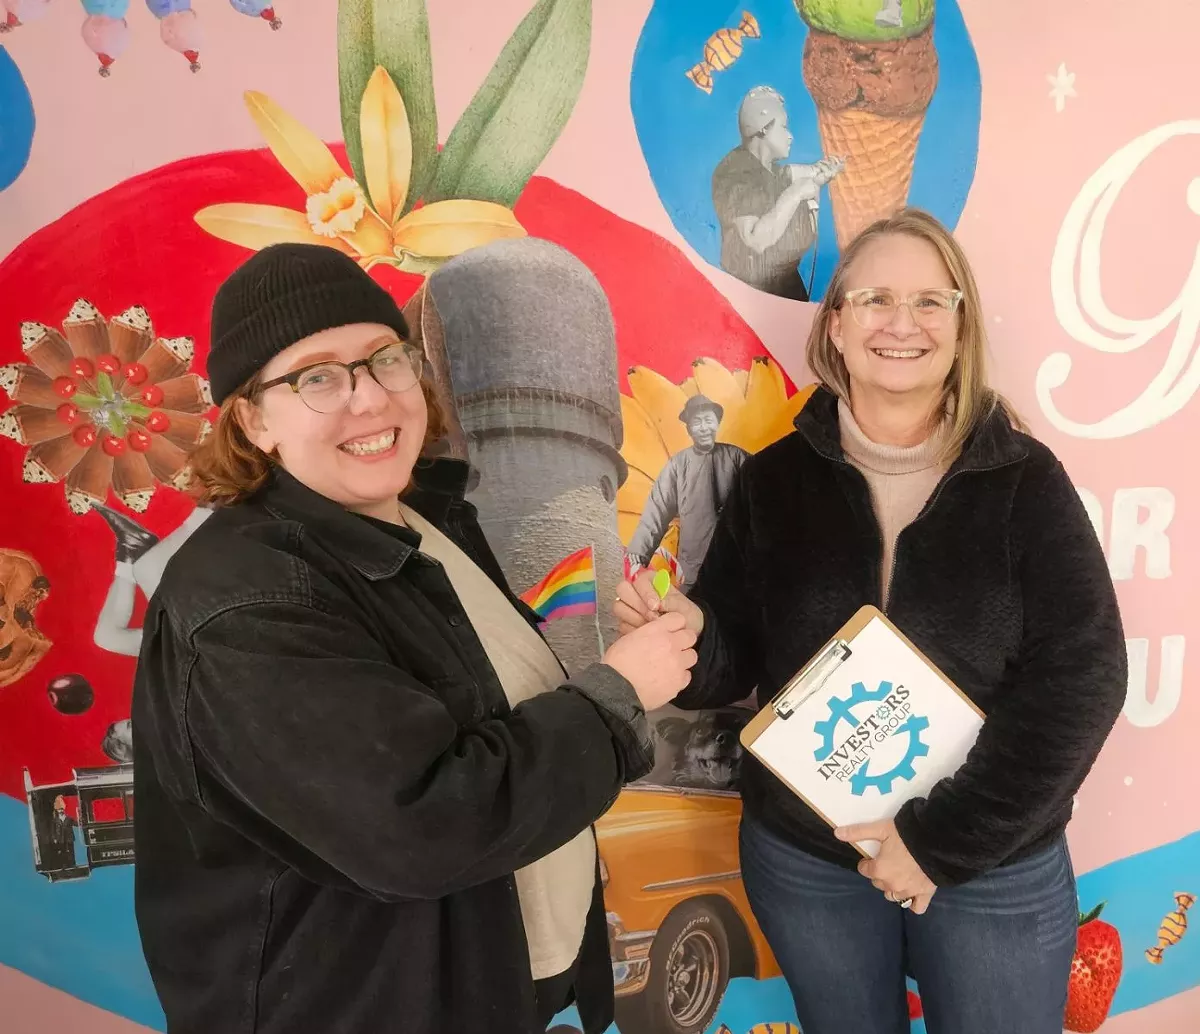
[630,0,982,302]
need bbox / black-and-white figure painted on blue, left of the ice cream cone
[713,86,845,301]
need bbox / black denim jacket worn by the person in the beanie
[133,459,652,1034]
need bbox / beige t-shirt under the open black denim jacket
[400,504,596,980]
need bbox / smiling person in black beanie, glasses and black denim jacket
[133,245,696,1034]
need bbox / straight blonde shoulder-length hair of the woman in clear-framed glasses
[806,208,1027,461]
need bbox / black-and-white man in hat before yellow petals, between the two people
[626,395,750,593]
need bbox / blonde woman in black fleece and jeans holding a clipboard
[614,209,1127,1034]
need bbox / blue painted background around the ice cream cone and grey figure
[630,0,982,299]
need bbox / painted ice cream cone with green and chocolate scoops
[794,0,937,247]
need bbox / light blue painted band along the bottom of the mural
[0,794,1200,1034]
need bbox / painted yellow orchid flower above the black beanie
[196,66,526,273]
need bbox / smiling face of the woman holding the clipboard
[829,234,959,407]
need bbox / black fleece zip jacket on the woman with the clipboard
[676,389,1128,886]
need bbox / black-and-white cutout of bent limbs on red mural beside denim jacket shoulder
[92,505,212,657]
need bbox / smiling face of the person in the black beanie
[238,323,428,521]
